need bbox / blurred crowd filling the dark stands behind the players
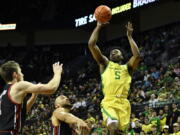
[0,23,180,135]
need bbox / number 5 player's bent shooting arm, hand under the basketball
[88,22,108,66]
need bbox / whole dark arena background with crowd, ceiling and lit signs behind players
[0,0,180,135]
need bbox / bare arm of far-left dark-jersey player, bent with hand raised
[14,62,62,94]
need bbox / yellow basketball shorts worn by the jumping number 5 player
[101,99,131,131]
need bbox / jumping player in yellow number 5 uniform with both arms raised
[88,22,140,135]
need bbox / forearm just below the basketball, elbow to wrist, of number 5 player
[88,25,101,46]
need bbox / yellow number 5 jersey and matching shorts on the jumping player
[101,61,132,131]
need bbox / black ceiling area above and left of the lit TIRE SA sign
[0,0,127,27]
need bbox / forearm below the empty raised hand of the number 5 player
[128,36,140,57]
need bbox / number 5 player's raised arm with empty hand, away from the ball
[126,22,140,70]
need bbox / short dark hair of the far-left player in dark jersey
[0,61,20,82]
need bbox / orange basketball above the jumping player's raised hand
[94,5,112,23]
